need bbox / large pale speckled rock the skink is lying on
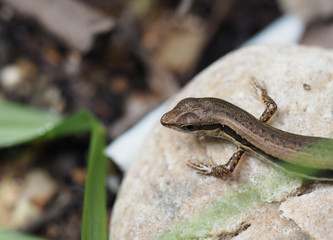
[110,46,333,240]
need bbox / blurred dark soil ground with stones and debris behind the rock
[0,0,333,239]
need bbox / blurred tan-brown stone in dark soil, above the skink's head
[143,14,205,74]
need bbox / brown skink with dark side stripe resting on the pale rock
[161,80,333,181]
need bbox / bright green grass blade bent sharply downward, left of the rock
[0,101,107,240]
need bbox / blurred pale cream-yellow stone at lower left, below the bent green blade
[0,169,57,229]
